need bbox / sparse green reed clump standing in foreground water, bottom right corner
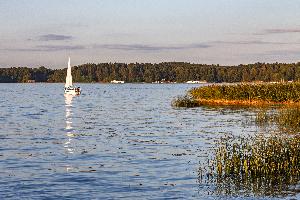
[209,135,300,196]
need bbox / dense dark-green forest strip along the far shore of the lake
[0,62,300,83]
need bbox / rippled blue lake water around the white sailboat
[0,84,300,199]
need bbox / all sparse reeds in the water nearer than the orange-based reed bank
[199,106,300,197]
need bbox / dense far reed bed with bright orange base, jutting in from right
[178,82,300,106]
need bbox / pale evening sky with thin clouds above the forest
[0,0,300,68]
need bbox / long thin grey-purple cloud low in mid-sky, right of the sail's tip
[92,44,210,51]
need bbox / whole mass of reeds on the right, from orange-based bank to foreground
[188,82,300,197]
